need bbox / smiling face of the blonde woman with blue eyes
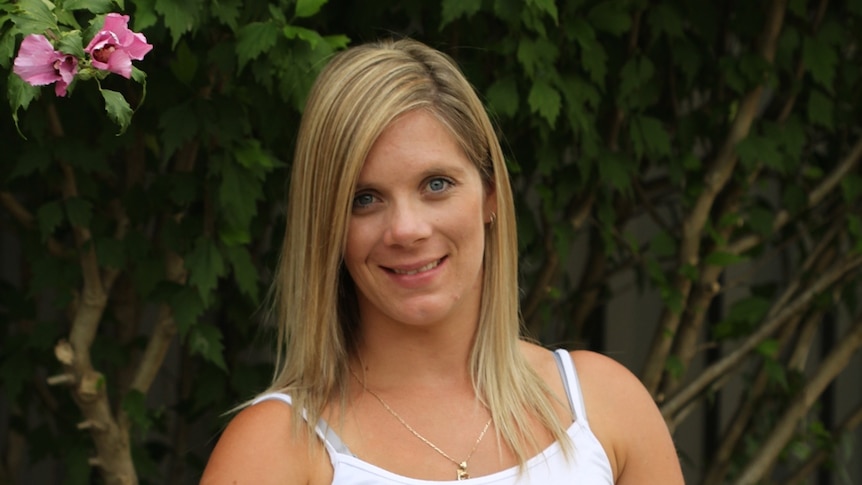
[344,110,494,325]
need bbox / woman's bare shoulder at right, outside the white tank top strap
[571,351,683,485]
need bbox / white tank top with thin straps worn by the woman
[253,349,614,485]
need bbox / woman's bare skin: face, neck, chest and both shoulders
[201,111,683,485]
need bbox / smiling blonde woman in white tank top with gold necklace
[202,40,682,485]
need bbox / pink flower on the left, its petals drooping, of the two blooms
[12,34,78,96]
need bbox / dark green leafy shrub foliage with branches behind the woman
[0,0,862,484]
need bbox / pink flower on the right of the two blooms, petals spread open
[84,13,153,79]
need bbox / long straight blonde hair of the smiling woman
[267,39,568,465]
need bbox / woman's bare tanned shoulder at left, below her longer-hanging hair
[200,401,331,485]
